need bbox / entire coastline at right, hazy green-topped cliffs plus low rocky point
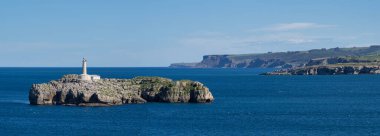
[169,45,380,75]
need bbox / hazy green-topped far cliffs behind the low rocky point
[169,45,380,68]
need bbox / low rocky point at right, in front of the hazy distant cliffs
[263,66,380,75]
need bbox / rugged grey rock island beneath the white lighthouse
[29,75,214,106]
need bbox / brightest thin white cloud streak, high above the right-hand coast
[262,22,334,31]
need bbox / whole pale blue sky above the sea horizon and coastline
[0,0,380,67]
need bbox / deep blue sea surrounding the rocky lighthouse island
[0,68,380,136]
